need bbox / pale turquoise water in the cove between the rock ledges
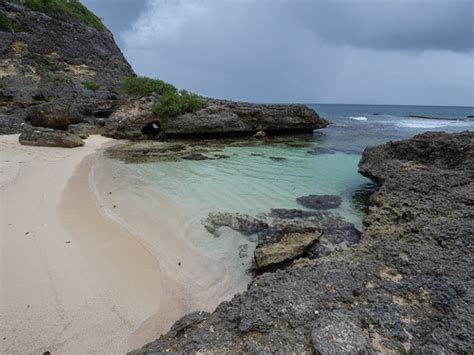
[133,144,369,227]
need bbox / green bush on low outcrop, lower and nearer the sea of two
[153,90,206,117]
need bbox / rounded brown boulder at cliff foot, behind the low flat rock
[26,100,94,130]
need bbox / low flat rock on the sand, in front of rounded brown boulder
[19,128,84,148]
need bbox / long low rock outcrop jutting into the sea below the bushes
[104,96,328,139]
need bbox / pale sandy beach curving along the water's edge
[0,136,188,354]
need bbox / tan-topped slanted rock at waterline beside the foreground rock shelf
[255,232,321,270]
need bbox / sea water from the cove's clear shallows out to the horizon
[91,104,474,309]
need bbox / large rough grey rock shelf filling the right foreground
[131,132,474,354]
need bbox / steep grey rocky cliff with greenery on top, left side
[0,0,133,133]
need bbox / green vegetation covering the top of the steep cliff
[13,0,106,31]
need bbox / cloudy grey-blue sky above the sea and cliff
[82,0,474,106]
